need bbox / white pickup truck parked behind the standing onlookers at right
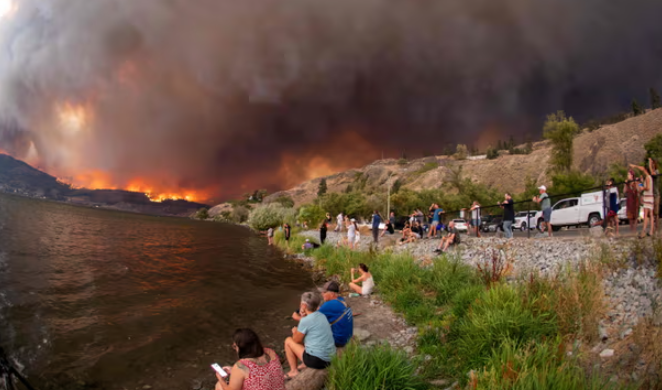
[535,191,604,230]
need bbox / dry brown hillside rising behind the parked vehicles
[258,109,662,205]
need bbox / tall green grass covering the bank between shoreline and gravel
[274,233,611,390]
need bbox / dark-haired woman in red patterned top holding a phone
[215,329,285,390]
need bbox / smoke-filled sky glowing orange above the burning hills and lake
[0,0,662,199]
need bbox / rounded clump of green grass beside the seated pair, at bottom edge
[326,343,429,390]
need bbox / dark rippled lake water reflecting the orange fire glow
[0,194,312,389]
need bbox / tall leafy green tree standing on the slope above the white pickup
[543,111,579,172]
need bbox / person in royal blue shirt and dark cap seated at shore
[292,281,354,348]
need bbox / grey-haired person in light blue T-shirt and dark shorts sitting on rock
[285,292,336,379]
